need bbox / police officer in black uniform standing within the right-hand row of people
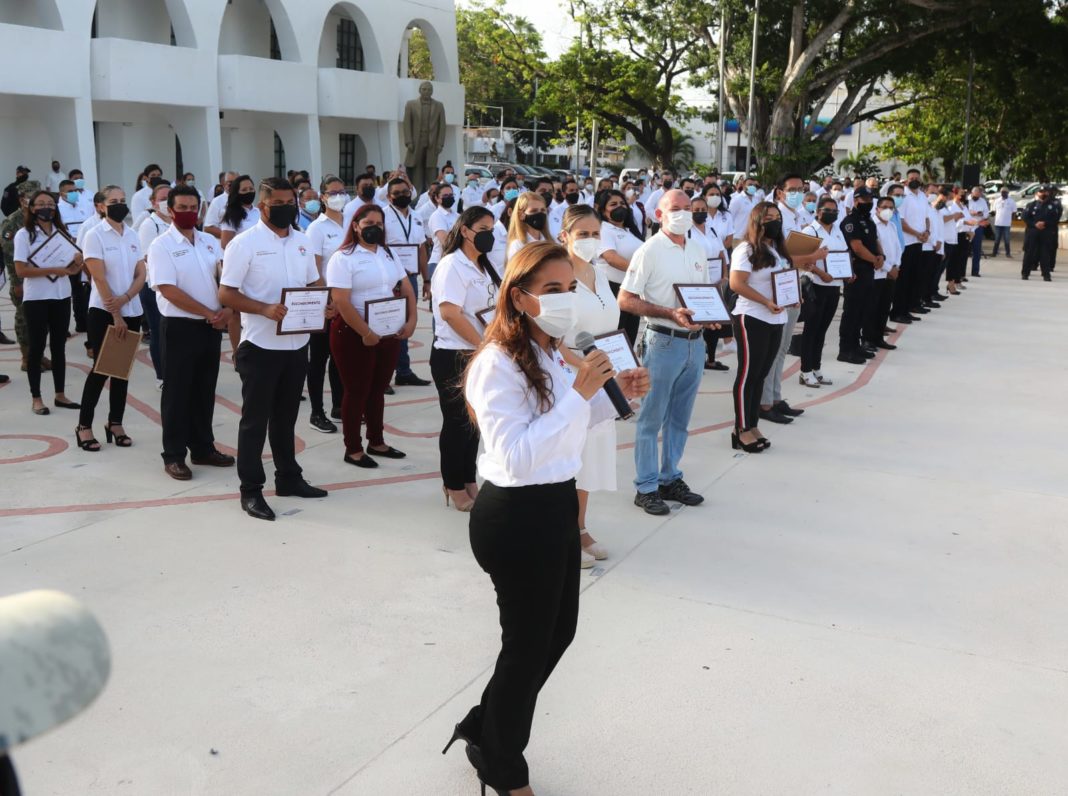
[838,187,884,364]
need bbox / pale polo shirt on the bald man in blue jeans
[619,230,708,329]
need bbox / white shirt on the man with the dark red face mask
[148,224,222,321]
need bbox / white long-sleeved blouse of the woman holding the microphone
[465,344,615,487]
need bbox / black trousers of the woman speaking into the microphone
[460,480,579,791]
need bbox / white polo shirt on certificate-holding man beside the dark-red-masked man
[219,221,319,350]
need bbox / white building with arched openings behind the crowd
[0,0,464,190]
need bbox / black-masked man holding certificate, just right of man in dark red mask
[219,177,327,520]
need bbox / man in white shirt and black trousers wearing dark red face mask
[147,185,234,481]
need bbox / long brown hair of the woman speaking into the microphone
[464,241,570,412]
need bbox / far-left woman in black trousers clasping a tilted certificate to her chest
[12,190,81,415]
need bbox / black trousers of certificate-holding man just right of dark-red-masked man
[230,341,308,495]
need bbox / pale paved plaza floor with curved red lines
[0,251,1068,796]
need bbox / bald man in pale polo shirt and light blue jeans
[619,189,719,515]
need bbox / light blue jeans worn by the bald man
[634,329,705,494]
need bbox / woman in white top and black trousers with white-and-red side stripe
[731,202,790,453]
